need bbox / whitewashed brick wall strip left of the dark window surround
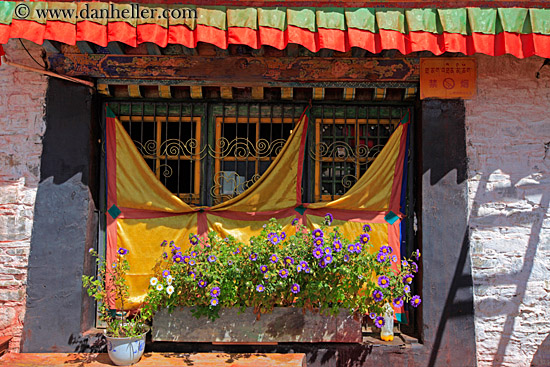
[0,40,47,351]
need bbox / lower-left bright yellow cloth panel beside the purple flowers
[117,213,197,310]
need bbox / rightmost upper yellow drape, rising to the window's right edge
[308,125,404,212]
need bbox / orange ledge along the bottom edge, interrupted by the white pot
[0,353,306,367]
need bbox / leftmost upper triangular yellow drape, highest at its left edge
[115,119,193,213]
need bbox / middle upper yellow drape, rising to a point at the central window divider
[210,110,307,212]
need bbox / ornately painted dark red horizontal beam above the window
[48,54,420,87]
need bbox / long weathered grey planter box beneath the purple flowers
[152,307,362,344]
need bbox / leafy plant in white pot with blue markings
[82,248,152,366]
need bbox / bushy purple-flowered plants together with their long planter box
[144,214,420,342]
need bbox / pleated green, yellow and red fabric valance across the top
[0,1,550,58]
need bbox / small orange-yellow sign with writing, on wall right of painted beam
[420,57,477,99]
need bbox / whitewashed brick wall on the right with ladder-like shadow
[466,56,550,367]
